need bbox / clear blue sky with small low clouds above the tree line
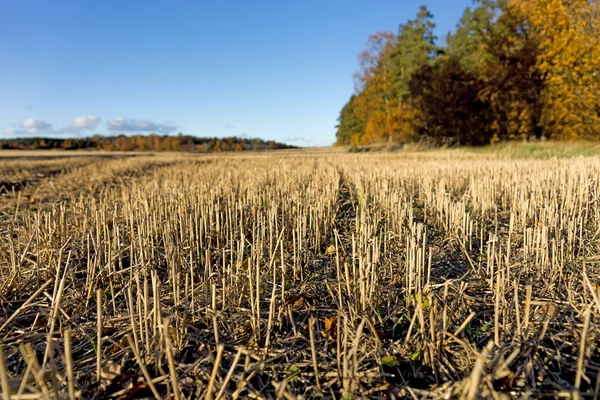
[0,0,471,146]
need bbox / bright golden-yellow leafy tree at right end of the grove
[510,0,600,139]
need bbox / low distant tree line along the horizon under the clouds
[0,134,294,153]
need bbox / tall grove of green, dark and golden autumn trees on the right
[337,0,600,145]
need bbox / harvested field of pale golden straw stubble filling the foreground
[0,148,600,399]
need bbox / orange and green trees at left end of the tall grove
[338,6,439,144]
